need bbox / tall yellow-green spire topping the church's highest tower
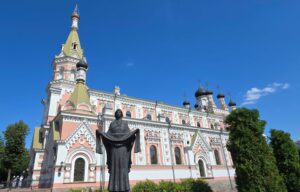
[62,4,83,59]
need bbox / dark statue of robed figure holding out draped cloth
[96,109,141,192]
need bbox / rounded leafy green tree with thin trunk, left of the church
[3,121,29,184]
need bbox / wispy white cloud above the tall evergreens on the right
[241,83,290,105]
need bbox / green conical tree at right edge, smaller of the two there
[270,129,300,192]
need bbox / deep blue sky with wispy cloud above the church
[0,0,300,146]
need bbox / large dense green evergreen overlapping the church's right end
[225,108,287,192]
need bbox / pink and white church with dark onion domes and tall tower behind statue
[28,8,236,190]
